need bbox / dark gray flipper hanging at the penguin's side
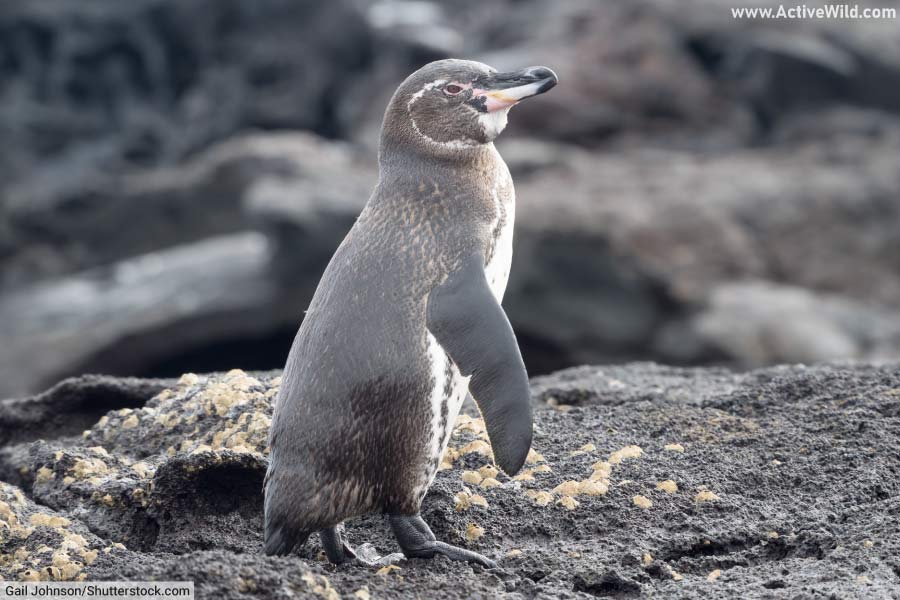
[426,254,532,475]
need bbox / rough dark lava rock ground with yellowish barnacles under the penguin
[0,363,900,598]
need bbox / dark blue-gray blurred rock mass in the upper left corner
[0,0,373,180]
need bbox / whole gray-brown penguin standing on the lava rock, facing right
[264,59,557,568]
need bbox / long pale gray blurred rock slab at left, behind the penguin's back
[0,233,278,396]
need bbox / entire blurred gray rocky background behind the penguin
[0,0,900,397]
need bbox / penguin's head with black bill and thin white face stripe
[382,59,557,153]
